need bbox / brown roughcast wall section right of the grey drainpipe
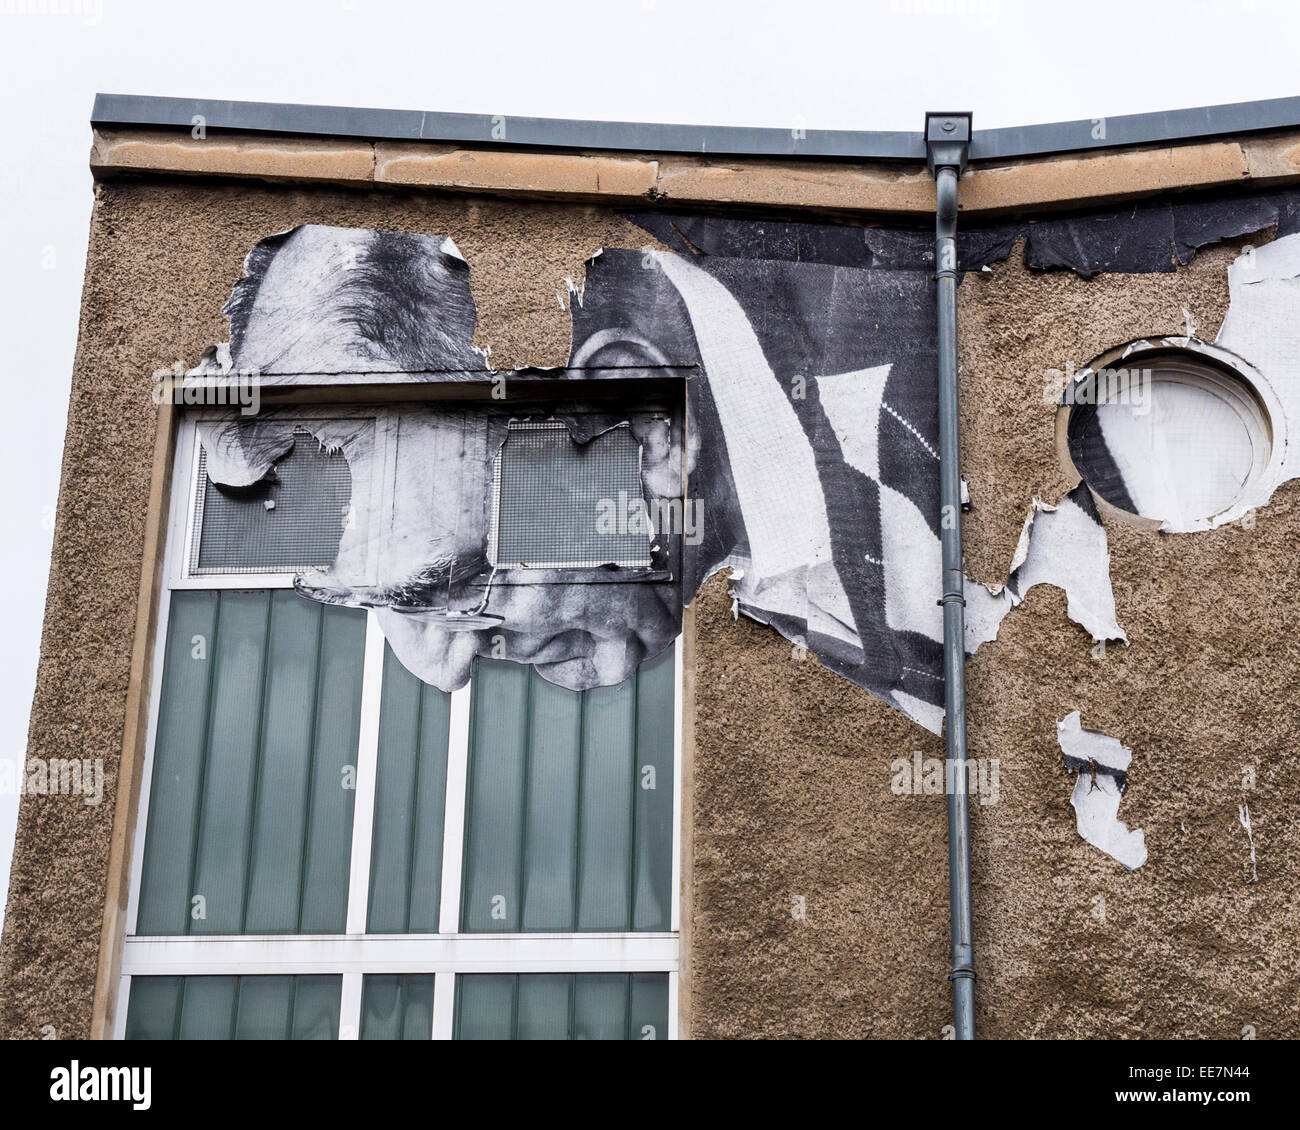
[959,233,1300,1039]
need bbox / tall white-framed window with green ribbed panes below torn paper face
[117,410,680,1039]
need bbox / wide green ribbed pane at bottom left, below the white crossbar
[126,975,343,1040]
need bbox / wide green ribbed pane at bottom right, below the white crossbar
[455,973,668,1040]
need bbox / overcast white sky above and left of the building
[0,0,1300,931]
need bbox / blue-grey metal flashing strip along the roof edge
[91,94,1300,161]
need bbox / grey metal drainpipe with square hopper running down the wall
[926,113,975,1040]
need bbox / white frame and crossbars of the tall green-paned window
[113,407,683,1039]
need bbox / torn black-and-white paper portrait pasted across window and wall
[191,226,1123,732]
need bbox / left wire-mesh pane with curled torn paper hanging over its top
[190,428,352,576]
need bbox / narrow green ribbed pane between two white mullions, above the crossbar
[368,645,451,934]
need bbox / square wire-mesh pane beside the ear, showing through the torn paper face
[490,420,650,568]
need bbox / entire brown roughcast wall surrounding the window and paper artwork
[0,179,1300,1038]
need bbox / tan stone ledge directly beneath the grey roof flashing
[90,129,1300,217]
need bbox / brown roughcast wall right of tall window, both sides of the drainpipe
[693,237,1300,1039]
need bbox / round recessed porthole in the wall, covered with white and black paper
[1062,348,1273,529]
